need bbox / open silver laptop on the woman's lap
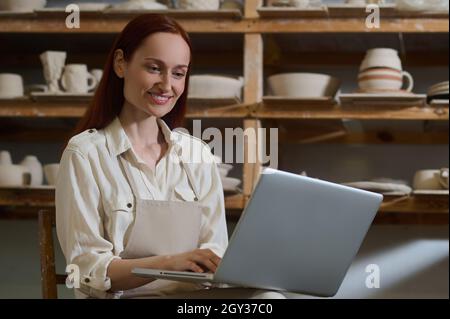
[132,168,383,297]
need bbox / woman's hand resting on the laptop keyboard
[167,249,221,272]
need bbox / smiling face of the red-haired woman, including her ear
[114,32,191,117]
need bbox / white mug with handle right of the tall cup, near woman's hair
[61,64,97,93]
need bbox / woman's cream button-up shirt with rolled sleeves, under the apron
[55,118,228,296]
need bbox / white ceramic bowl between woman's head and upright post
[189,74,244,99]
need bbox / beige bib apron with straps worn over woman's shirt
[119,150,207,298]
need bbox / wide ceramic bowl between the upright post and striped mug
[267,73,340,98]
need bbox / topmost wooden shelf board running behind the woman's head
[0,14,449,34]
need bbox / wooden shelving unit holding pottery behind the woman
[0,0,449,223]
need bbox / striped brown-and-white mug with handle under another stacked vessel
[358,68,414,92]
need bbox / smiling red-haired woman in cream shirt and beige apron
[56,15,284,298]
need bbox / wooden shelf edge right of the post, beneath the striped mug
[252,104,449,120]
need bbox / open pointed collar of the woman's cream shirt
[105,116,177,156]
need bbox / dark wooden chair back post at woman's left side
[38,208,66,299]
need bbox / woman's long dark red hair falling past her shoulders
[73,14,192,141]
